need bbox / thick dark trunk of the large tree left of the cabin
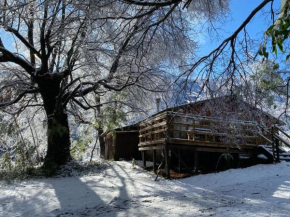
[38,78,71,167]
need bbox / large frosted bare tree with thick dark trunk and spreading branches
[0,0,226,165]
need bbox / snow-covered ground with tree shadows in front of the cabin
[0,162,290,217]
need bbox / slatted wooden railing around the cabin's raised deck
[138,111,269,150]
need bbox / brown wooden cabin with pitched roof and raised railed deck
[138,96,284,178]
